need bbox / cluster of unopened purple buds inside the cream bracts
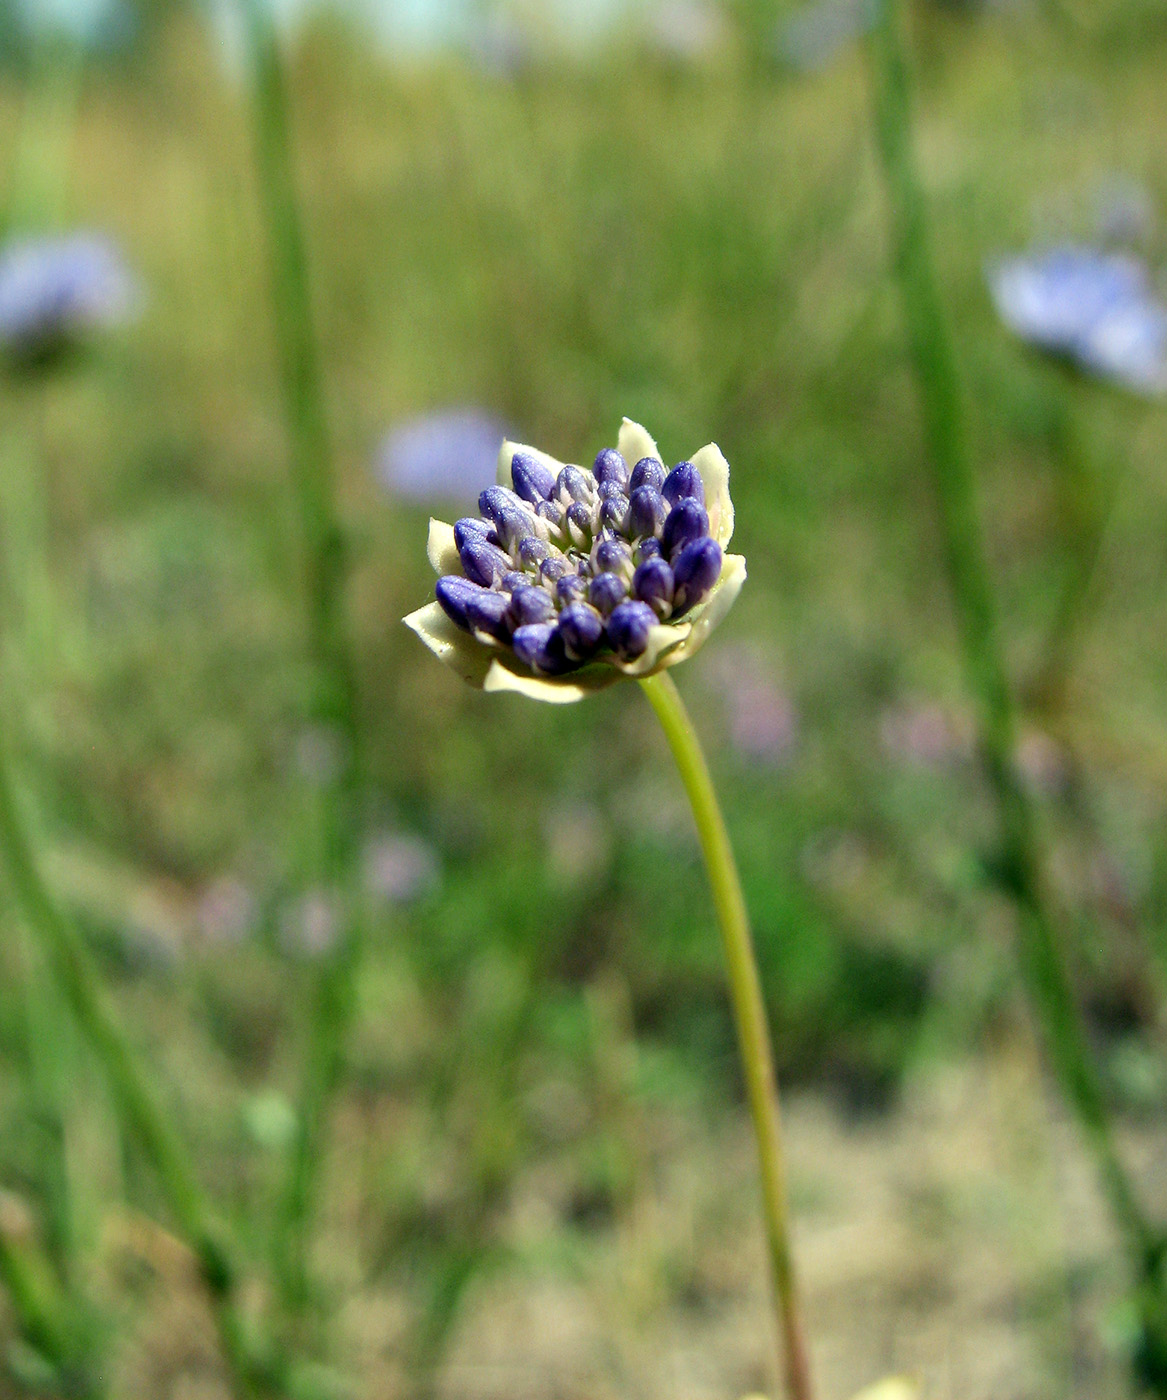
[437,448,722,675]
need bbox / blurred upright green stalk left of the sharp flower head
[235,0,361,1315]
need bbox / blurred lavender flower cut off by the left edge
[0,234,141,354]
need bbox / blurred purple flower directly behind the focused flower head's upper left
[376,409,508,504]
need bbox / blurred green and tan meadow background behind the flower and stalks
[0,0,1167,1400]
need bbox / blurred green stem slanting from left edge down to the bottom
[0,738,270,1396]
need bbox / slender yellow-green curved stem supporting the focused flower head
[641,672,813,1400]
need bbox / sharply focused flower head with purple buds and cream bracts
[404,419,746,703]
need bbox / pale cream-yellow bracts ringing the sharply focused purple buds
[403,419,746,704]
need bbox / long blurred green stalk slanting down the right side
[870,0,1167,1377]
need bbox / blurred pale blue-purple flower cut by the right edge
[988,245,1167,393]
